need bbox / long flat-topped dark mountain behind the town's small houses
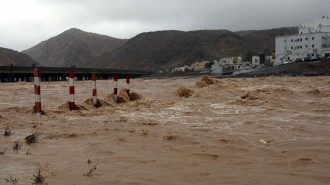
[98,27,298,71]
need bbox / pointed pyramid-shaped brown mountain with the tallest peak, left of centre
[22,28,127,67]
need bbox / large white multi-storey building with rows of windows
[275,18,330,65]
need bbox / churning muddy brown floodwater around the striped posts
[0,77,330,185]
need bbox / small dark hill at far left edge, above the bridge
[0,47,38,66]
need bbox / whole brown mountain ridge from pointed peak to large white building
[23,27,298,71]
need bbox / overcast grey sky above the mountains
[0,0,330,51]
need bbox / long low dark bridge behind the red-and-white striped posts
[0,66,151,82]
